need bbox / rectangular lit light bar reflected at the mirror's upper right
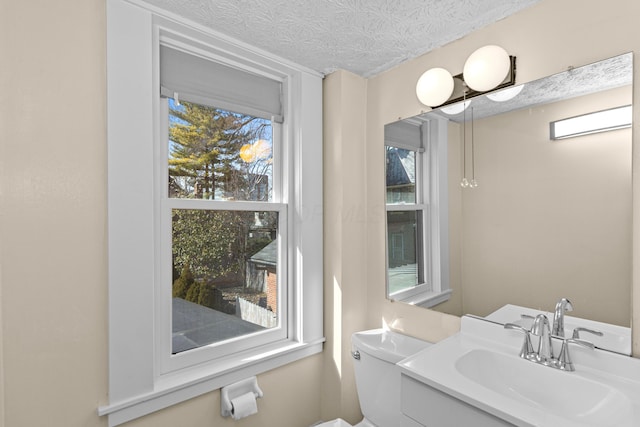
[549,105,633,140]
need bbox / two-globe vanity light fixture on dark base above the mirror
[416,45,515,108]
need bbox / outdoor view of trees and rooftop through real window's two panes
[168,99,278,353]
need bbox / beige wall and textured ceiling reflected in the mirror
[385,53,633,334]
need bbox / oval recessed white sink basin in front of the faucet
[455,349,633,426]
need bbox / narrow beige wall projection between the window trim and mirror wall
[322,71,370,423]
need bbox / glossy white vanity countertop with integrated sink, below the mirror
[398,316,640,427]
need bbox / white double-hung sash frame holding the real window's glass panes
[154,42,291,374]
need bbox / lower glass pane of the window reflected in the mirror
[387,211,423,295]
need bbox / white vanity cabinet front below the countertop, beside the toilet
[400,374,514,427]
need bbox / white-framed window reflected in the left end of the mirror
[385,120,450,307]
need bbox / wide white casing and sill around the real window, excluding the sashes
[98,0,324,426]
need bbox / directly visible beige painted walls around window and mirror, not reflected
[0,0,640,427]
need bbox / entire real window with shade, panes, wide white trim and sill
[99,0,324,426]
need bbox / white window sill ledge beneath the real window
[98,338,325,427]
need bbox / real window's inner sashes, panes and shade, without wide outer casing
[156,40,290,372]
